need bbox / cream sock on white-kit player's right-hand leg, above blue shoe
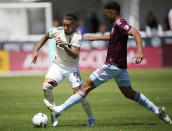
[81,98,94,120]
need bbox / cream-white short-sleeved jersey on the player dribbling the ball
[48,27,82,66]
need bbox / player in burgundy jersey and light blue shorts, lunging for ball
[49,2,172,124]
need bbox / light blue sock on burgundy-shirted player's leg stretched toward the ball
[60,91,86,112]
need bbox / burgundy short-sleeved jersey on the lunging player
[105,18,131,69]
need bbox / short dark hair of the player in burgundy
[104,2,120,14]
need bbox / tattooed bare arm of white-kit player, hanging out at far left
[31,33,49,64]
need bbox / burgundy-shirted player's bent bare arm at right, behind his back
[129,27,143,64]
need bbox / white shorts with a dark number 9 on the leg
[45,63,82,88]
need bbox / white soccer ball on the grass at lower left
[32,113,48,128]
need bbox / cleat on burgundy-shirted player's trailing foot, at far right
[159,107,172,124]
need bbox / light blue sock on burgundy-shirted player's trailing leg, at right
[137,93,160,115]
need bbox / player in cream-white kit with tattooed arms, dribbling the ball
[32,14,95,126]
